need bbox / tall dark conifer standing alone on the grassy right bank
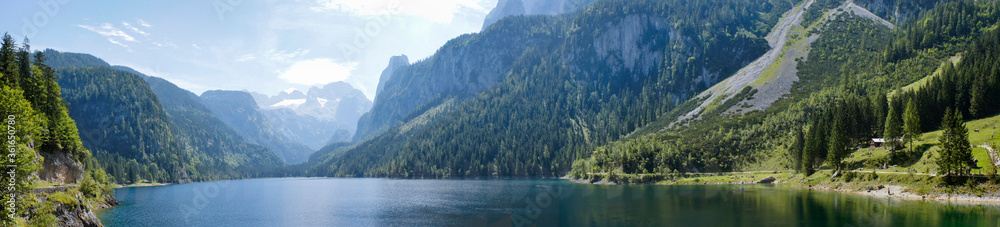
[937,108,972,175]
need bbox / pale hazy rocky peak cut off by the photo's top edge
[483,0,595,30]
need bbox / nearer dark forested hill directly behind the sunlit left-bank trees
[57,65,189,183]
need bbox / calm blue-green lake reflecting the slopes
[98,178,1000,226]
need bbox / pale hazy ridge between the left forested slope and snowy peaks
[201,91,312,164]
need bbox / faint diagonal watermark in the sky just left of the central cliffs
[339,0,402,60]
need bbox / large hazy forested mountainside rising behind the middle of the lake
[310,0,793,177]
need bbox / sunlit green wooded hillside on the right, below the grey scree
[571,0,1000,182]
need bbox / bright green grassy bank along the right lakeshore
[659,115,1000,199]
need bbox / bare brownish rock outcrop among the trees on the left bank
[38,152,84,184]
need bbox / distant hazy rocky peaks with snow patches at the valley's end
[253,82,372,150]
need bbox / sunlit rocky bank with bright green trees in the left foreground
[0,33,115,226]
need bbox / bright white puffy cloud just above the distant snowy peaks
[280,58,358,86]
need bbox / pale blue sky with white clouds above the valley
[0,0,497,99]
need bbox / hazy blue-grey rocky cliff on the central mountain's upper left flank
[354,18,558,141]
